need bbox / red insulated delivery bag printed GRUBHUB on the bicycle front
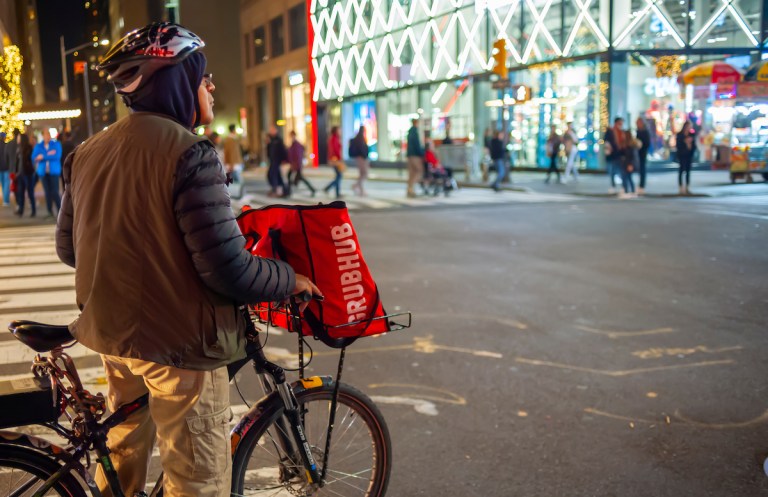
[237,202,391,347]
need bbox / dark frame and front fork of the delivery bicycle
[0,306,333,497]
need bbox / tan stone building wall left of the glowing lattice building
[239,0,312,160]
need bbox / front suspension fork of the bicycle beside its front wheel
[255,362,325,487]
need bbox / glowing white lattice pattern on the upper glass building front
[310,0,759,100]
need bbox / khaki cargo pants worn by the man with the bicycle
[96,355,232,497]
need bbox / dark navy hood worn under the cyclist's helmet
[131,52,206,129]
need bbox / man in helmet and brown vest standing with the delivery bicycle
[56,23,319,497]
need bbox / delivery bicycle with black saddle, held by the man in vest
[0,296,410,497]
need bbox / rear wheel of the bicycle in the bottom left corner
[0,444,87,497]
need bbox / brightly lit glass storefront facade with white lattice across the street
[310,0,768,168]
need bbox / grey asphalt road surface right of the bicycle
[242,200,768,497]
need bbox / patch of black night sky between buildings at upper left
[37,0,88,102]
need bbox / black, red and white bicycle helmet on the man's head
[98,22,205,107]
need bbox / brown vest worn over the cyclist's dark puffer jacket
[70,112,244,370]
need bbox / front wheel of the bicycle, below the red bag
[232,383,392,497]
